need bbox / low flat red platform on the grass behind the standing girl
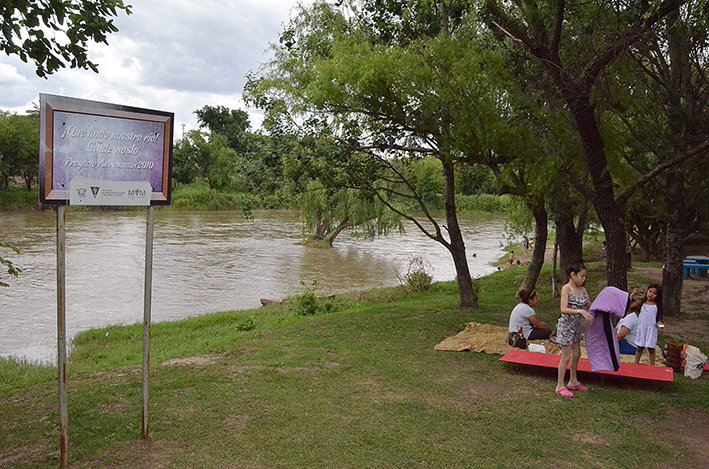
[500,350,674,383]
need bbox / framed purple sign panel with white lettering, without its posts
[40,94,174,205]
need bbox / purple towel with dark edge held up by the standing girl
[586,287,629,371]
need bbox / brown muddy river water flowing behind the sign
[0,210,504,362]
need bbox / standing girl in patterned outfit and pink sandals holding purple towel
[556,262,593,397]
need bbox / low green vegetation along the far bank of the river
[0,181,512,213]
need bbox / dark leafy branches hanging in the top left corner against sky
[0,0,131,77]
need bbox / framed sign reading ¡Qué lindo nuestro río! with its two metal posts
[39,94,175,469]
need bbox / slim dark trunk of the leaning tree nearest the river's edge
[443,159,478,308]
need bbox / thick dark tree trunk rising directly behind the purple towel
[567,95,628,291]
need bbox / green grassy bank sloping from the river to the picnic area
[0,265,709,469]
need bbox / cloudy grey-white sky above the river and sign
[0,0,307,137]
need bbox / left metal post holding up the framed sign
[57,205,69,469]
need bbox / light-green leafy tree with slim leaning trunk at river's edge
[247,2,512,307]
